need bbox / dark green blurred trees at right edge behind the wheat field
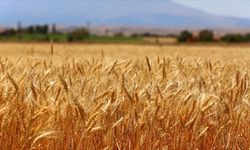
[177,30,250,43]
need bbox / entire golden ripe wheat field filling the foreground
[0,43,250,150]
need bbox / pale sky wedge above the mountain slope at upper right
[173,0,250,18]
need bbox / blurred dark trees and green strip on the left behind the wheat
[0,25,143,43]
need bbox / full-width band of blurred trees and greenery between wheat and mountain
[0,24,250,44]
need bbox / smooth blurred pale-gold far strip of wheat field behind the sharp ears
[0,42,250,60]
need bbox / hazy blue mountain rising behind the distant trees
[0,0,250,28]
